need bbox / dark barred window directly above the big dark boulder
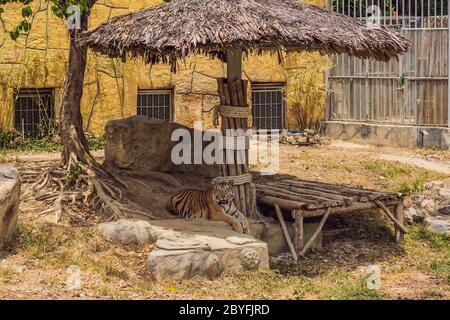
[137,90,172,121]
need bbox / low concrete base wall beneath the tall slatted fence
[324,121,450,149]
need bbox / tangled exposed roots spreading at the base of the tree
[22,154,157,224]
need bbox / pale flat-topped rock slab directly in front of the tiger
[98,219,269,280]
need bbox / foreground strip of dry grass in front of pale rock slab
[0,214,450,299]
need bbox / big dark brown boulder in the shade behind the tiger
[105,116,219,177]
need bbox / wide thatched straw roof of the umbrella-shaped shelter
[80,0,410,67]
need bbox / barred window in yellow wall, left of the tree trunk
[14,89,54,137]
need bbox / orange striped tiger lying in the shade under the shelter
[168,179,250,234]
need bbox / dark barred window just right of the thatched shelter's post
[252,84,284,130]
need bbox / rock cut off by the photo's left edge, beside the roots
[0,166,20,250]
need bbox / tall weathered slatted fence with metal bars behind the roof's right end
[327,0,450,126]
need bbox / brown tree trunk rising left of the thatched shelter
[60,13,95,165]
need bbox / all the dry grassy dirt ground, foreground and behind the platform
[0,141,450,299]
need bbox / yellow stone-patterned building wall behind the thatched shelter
[0,0,327,133]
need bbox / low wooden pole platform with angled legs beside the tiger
[256,180,407,259]
